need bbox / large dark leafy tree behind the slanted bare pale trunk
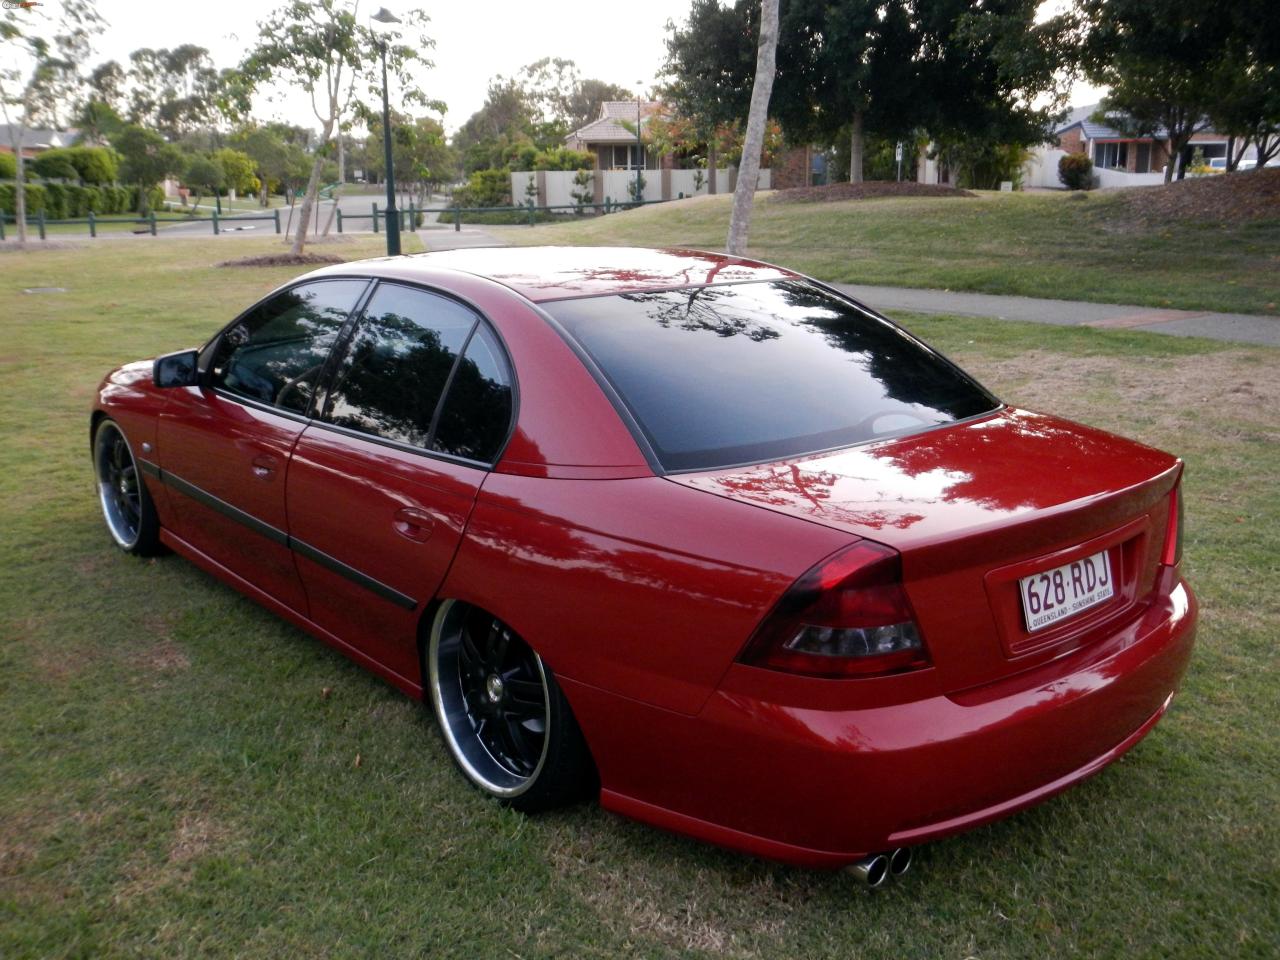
[667,0,1078,180]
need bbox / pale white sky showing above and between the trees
[64,0,1100,133]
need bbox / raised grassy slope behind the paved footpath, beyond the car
[504,192,1280,315]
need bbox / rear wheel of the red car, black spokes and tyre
[426,600,594,813]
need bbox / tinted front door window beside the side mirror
[210,280,367,413]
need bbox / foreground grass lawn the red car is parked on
[0,239,1280,960]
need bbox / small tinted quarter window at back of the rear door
[433,326,511,463]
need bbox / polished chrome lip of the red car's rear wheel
[426,600,552,799]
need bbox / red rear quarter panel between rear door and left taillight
[442,474,855,716]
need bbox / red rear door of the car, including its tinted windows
[288,283,512,684]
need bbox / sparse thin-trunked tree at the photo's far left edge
[0,0,102,243]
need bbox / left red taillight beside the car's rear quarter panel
[740,540,929,677]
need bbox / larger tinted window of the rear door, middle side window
[324,284,476,447]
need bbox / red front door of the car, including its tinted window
[156,280,369,613]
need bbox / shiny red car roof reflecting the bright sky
[308,247,797,302]
